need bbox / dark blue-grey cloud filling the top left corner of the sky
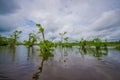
[0,0,19,15]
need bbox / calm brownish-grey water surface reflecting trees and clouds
[0,46,120,80]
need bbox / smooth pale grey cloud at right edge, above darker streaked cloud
[93,9,120,31]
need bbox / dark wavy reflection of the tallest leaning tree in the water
[33,50,54,80]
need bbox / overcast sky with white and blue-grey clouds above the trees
[0,0,120,41]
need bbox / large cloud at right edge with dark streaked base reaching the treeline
[90,9,120,39]
